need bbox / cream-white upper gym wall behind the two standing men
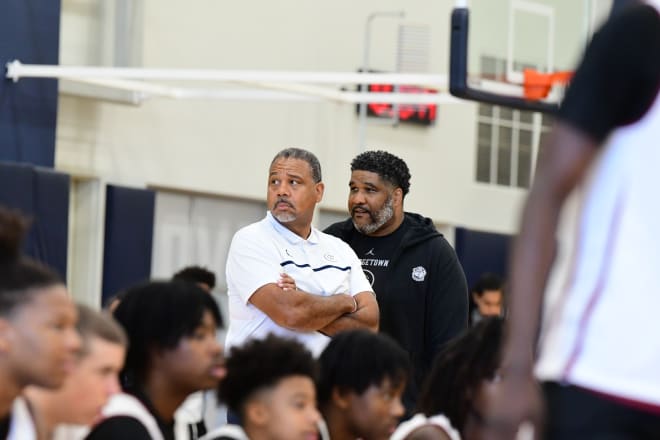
[56,0,608,237]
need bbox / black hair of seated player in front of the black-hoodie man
[318,330,411,406]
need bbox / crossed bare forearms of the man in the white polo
[249,274,378,336]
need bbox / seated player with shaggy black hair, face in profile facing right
[88,281,225,440]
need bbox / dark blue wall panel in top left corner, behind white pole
[0,0,60,167]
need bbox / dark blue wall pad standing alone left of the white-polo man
[103,185,156,303]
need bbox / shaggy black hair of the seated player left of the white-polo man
[114,281,222,388]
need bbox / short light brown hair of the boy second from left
[76,304,128,357]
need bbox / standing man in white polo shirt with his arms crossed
[226,148,378,356]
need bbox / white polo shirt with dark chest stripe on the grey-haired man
[225,212,372,356]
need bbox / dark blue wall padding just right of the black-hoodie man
[455,228,513,289]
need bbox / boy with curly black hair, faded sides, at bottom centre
[204,334,321,440]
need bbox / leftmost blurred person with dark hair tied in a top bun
[0,207,80,439]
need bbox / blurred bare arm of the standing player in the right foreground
[475,122,598,440]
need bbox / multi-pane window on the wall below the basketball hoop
[476,56,552,188]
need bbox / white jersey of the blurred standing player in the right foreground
[536,80,660,406]
